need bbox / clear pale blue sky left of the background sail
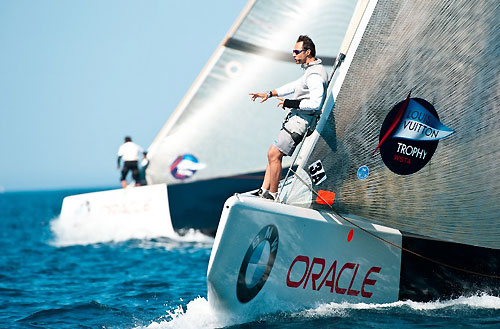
[0,0,247,192]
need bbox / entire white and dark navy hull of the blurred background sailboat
[56,168,264,242]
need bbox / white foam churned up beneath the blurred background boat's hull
[50,216,213,249]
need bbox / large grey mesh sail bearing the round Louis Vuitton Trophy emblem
[286,0,500,249]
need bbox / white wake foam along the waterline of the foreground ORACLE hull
[138,295,500,329]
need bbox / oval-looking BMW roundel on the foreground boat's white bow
[236,225,278,303]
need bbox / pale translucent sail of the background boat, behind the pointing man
[147,0,356,184]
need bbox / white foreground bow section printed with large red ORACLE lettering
[207,195,402,316]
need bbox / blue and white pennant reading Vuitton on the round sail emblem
[392,99,455,141]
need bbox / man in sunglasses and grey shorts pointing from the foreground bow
[250,35,328,200]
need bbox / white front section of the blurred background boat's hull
[52,184,174,243]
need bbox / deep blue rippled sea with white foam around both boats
[0,190,500,329]
